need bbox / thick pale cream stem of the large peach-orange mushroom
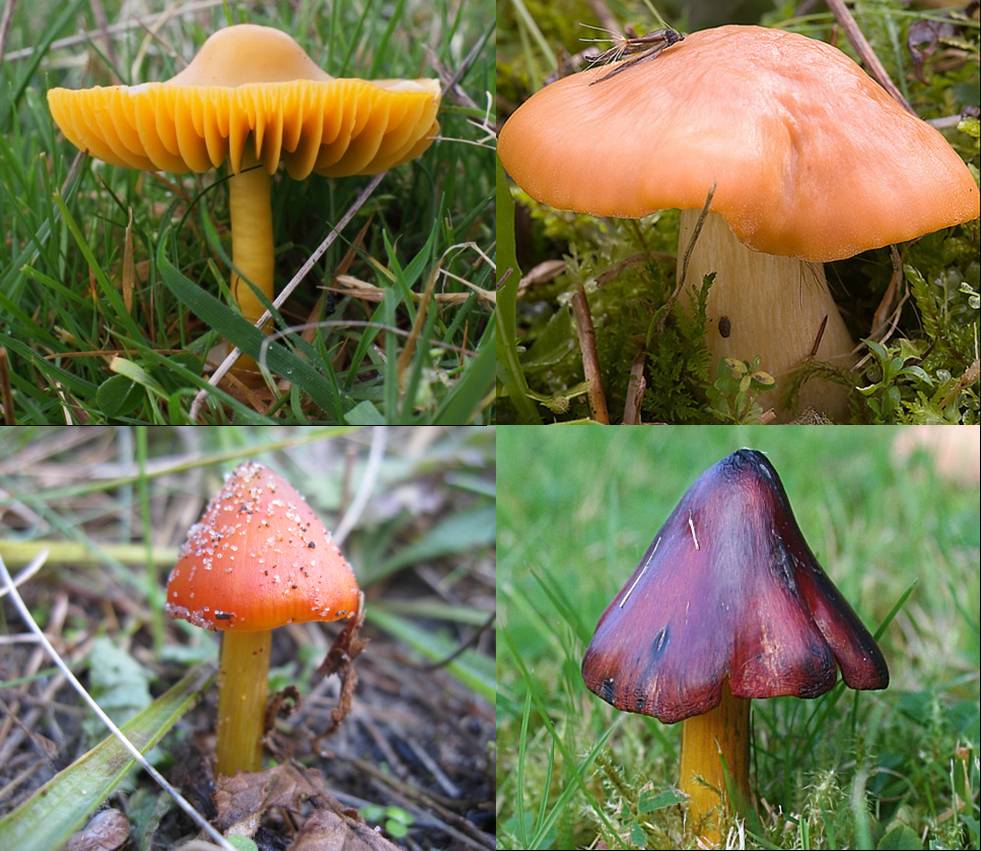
[678,210,855,422]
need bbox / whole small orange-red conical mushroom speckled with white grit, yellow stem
[167,462,361,774]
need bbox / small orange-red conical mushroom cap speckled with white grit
[167,462,360,632]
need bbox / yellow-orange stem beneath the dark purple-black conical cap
[680,681,749,848]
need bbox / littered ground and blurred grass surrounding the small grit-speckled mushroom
[0,428,494,849]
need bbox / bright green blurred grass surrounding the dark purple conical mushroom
[497,425,979,848]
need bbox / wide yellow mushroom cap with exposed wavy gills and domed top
[48,24,440,180]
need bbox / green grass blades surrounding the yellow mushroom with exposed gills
[0,0,494,424]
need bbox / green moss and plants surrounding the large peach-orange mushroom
[497,0,981,424]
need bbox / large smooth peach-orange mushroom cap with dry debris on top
[498,26,978,262]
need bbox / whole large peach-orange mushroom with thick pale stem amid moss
[498,26,978,418]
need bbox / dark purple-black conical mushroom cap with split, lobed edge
[582,449,889,723]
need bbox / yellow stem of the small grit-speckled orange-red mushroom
[215,629,272,775]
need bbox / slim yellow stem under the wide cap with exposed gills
[228,154,275,322]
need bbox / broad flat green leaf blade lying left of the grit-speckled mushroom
[0,665,215,851]
